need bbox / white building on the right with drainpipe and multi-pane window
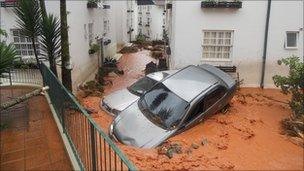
[167,0,304,87]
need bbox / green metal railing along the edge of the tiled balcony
[41,64,136,170]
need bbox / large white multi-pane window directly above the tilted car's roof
[202,30,233,60]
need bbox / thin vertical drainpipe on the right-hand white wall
[260,0,271,88]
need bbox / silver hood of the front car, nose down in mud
[113,101,174,148]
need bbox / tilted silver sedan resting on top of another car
[109,65,236,148]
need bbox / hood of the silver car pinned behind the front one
[101,89,139,111]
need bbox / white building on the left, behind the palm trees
[0,0,128,89]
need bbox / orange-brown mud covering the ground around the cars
[82,51,304,170]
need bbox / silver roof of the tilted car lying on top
[163,65,221,102]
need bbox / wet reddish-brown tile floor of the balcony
[0,87,72,171]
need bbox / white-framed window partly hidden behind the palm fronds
[11,29,40,56]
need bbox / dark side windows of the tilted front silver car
[185,86,226,124]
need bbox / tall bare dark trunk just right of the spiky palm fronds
[60,0,72,91]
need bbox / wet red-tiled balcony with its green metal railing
[0,64,136,170]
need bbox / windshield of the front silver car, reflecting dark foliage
[138,83,188,129]
